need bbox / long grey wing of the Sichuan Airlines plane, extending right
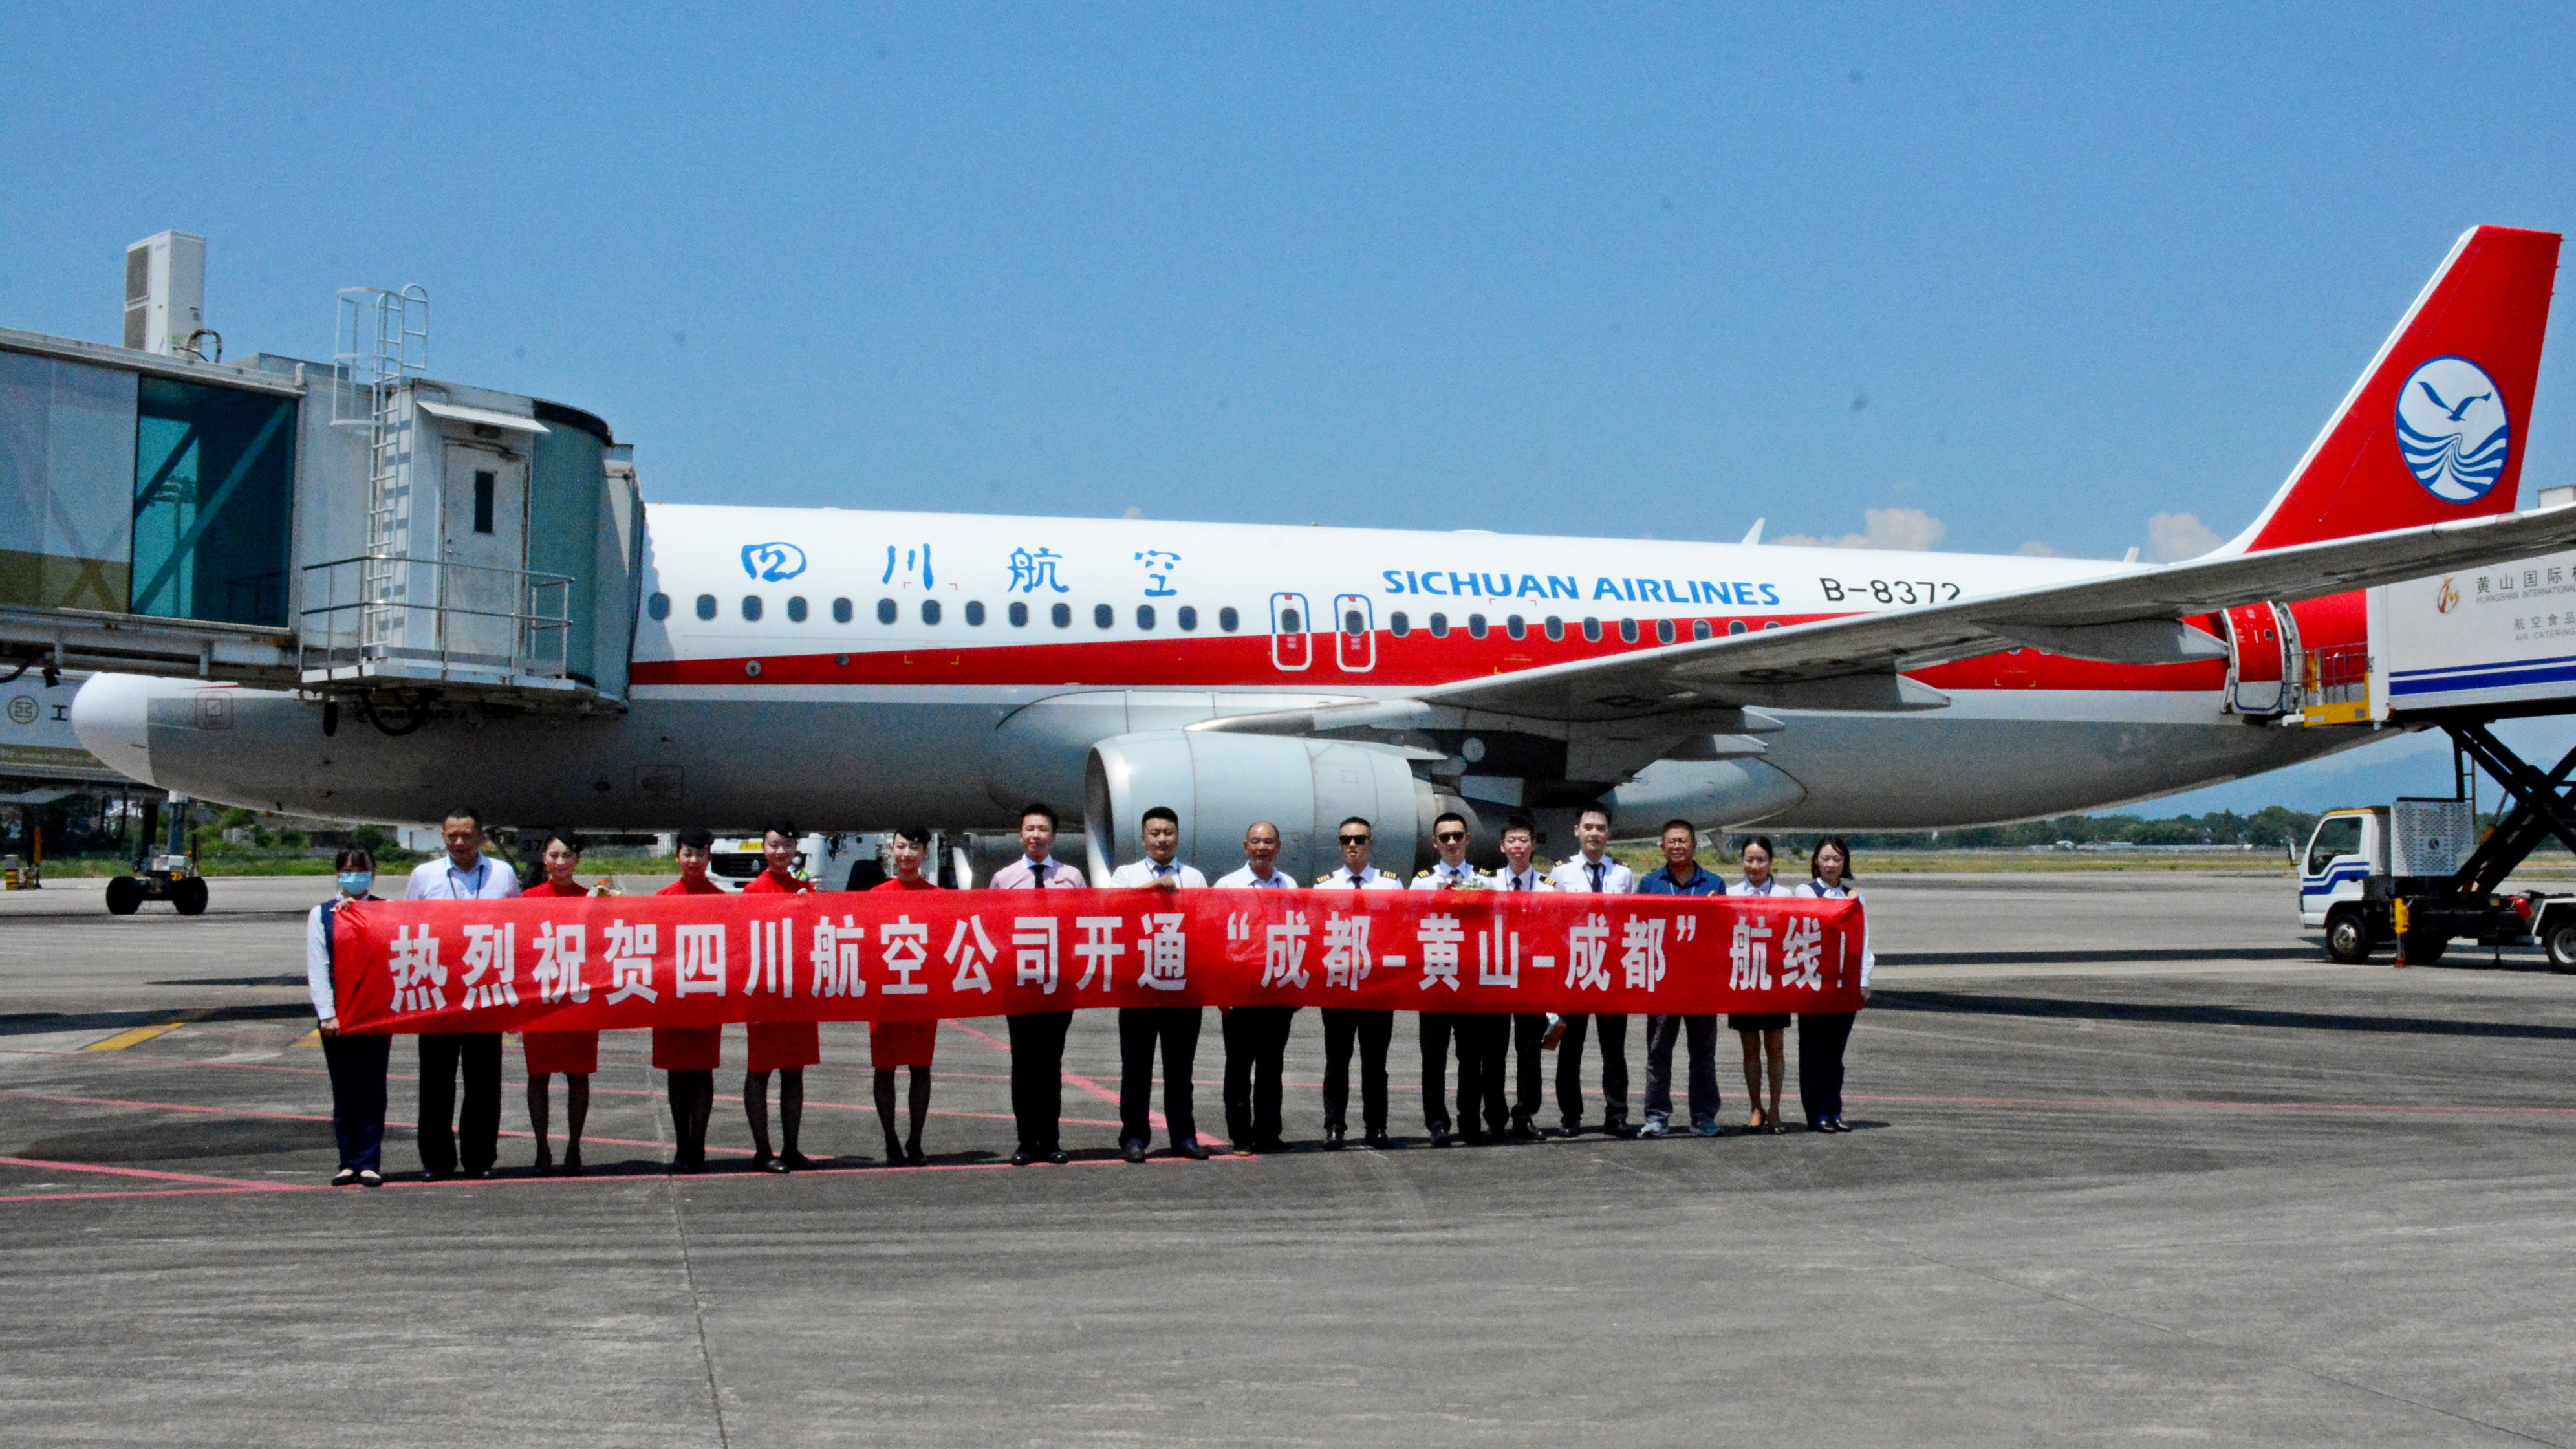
[1411,495,2576,727]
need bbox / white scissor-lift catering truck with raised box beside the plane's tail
[2293,510,2576,972]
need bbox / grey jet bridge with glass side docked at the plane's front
[0,247,644,732]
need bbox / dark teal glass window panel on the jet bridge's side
[131,376,296,627]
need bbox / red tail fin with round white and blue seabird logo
[2220,227,2558,554]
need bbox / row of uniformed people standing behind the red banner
[307,805,1873,1186]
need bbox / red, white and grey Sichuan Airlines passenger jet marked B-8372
[75,227,2576,874]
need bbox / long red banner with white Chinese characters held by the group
[332,889,1863,1034]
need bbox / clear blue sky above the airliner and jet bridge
[0,5,2576,802]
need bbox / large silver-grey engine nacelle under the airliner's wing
[1082,730,1440,884]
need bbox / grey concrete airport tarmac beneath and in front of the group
[0,861,2576,1449]
